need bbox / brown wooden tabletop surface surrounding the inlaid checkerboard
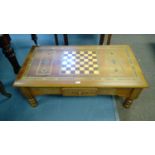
[14,45,148,88]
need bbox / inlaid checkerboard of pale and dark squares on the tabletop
[61,51,99,75]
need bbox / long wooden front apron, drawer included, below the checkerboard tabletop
[28,87,141,98]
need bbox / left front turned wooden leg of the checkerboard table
[20,88,37,107]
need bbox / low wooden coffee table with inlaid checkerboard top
[14,45,148,108]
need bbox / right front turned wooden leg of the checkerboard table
[123,88,142,108]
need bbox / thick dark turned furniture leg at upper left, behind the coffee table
[0,34,20,74]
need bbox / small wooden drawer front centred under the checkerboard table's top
[62,88,97,96]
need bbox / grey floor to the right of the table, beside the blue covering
[111,34,155,121]
